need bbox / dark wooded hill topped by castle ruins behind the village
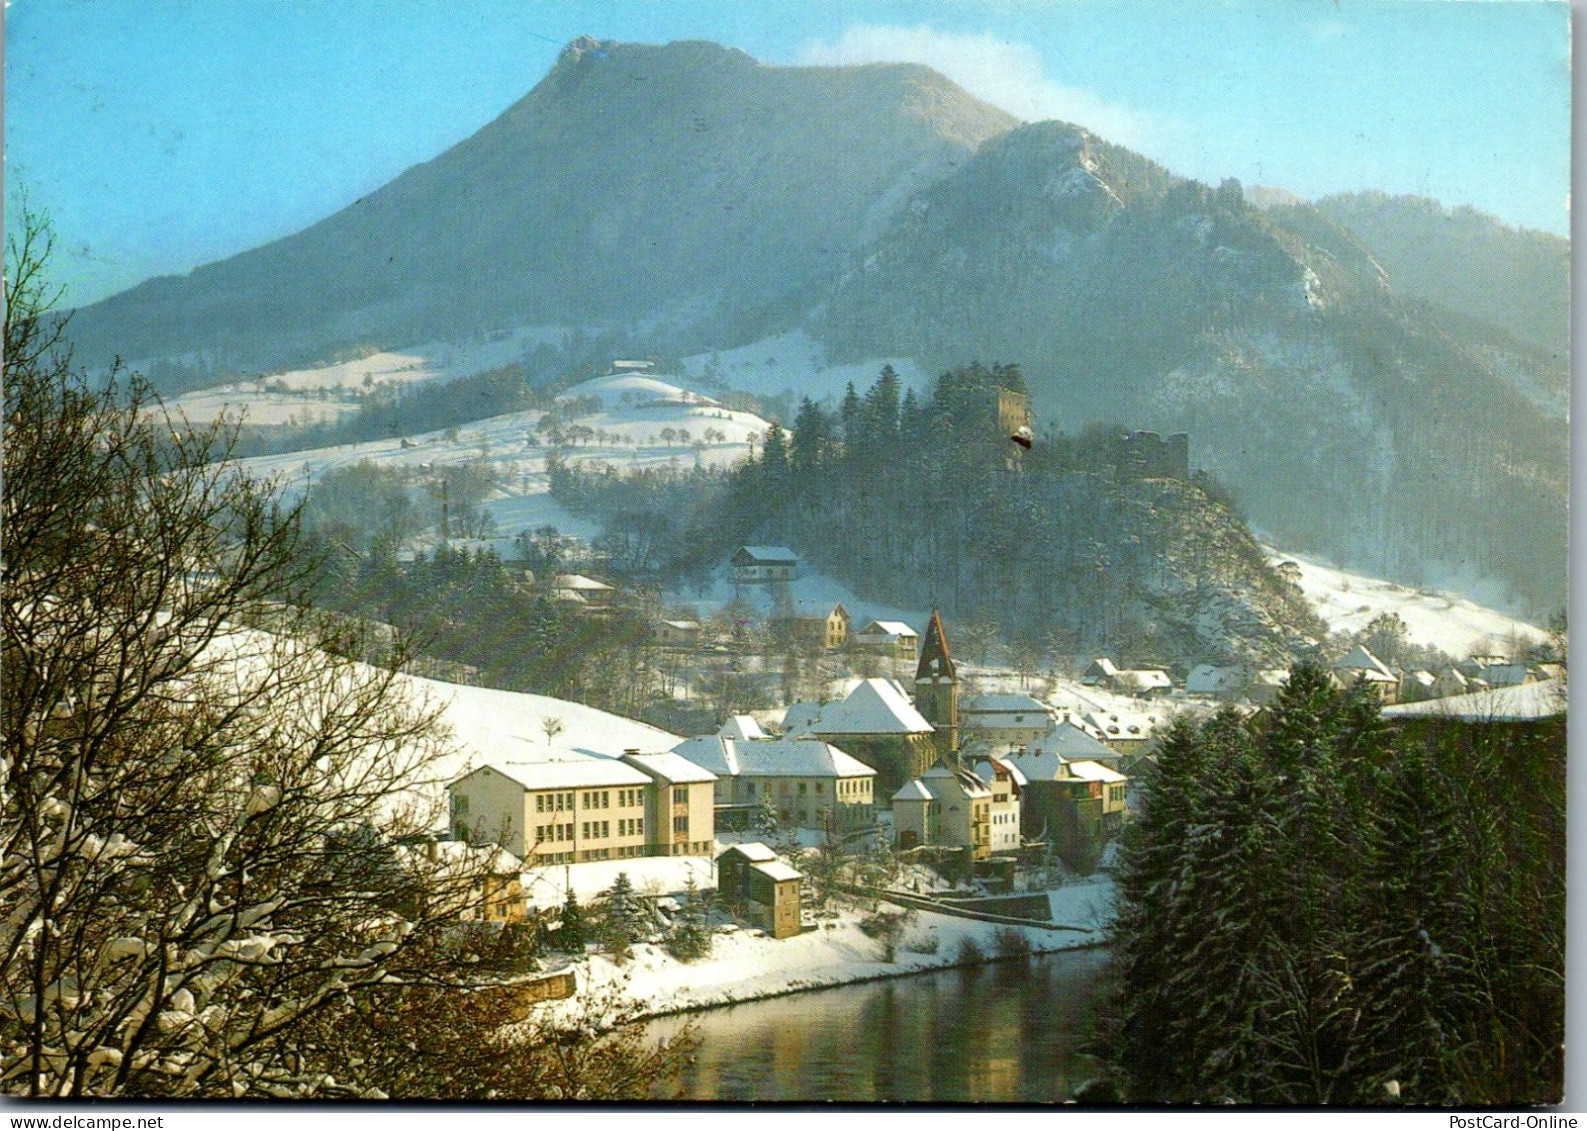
[552,365,1322,663]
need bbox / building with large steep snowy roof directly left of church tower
[782,679,938,788]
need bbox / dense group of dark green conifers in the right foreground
[1105,665,1565,1106]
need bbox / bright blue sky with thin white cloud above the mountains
[5,0,1570,305]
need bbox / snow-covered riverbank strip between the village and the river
[568,879,1112,1017]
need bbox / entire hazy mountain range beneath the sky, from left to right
[61,40,1568,611]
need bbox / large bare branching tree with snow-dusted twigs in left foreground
[0,217,685,1098]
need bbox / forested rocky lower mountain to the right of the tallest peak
[822,122,1566,609]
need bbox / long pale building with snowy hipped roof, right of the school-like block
[673,715,876,831]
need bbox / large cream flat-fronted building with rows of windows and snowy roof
[448,750,716,865]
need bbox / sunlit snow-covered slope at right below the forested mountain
[1266,547,1547,658]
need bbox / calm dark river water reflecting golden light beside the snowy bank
[652,950,1108,1102]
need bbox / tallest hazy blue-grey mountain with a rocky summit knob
[73,40,1014,370]
